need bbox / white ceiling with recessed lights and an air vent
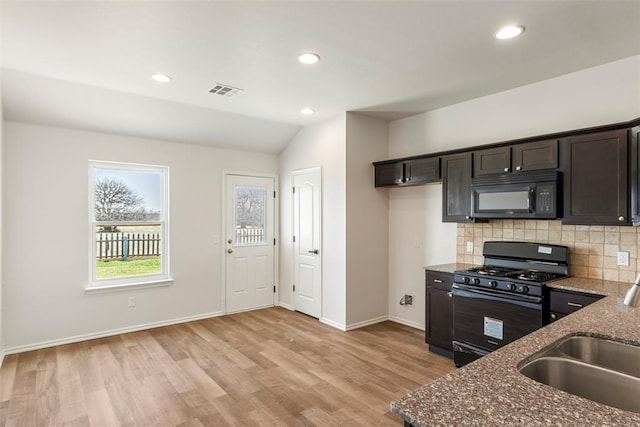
[0,0,640,153]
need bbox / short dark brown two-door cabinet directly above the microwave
[473,139,558,176]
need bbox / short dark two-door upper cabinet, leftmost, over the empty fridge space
[374,157,440,187]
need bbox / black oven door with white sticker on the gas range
[452,283,543,351]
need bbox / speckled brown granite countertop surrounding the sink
[391,278,640,426]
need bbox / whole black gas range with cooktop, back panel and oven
[452,241,569,366]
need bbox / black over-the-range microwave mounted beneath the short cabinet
[471,171,561,219]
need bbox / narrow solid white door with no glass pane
[293,169,322,318]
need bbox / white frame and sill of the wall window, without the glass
[86,160,173,291]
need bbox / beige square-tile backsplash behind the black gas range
[456,220,640,282]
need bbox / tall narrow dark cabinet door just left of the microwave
[442,153,473,222]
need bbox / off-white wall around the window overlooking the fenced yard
[2,122,278,352]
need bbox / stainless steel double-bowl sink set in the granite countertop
[520,335,640,413]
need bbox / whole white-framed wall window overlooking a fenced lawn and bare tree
[89,162,169,288]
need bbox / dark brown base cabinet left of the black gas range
[425,270,453,358]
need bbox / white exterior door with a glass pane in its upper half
[225,174,275,313]
